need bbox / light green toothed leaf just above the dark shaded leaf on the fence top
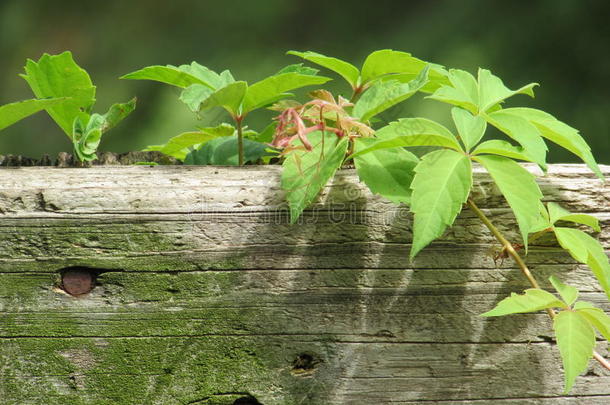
[144,124,235,161]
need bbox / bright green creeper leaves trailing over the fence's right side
[262,50,610,391]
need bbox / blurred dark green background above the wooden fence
[0,0,610,164]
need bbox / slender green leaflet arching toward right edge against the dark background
[496,108,604,179]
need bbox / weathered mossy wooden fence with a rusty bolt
[0,165,610,405]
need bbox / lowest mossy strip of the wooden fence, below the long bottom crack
[0,335,610,404]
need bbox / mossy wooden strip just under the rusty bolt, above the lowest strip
[0,266,610,343]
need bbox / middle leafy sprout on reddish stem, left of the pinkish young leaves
[122,62,330,165]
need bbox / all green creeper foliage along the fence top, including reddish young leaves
[0,49,610,391]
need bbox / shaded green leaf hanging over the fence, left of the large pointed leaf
[354,138,419,204]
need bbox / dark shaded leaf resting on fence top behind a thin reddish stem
[184,136,270,166]
